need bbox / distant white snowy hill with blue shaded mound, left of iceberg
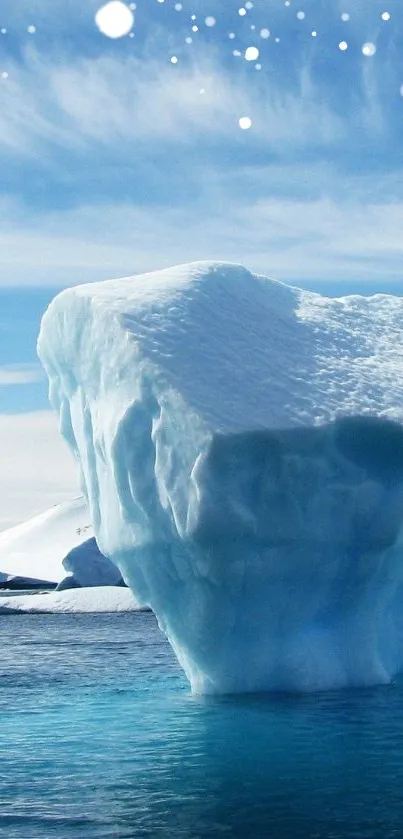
[0,496,121,586]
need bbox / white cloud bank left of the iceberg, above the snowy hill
[0,411,79,530]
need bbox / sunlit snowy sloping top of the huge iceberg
[40,262,403,433]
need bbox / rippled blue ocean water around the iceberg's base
[0,613,403,839]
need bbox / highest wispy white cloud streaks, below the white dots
[0,49,348,157]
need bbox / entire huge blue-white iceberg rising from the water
[38,263,403,692]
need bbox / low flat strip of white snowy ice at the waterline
[0,586,142,615]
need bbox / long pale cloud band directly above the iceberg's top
[0,194,403,286]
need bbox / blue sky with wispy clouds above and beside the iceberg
[0,0,403,528]
